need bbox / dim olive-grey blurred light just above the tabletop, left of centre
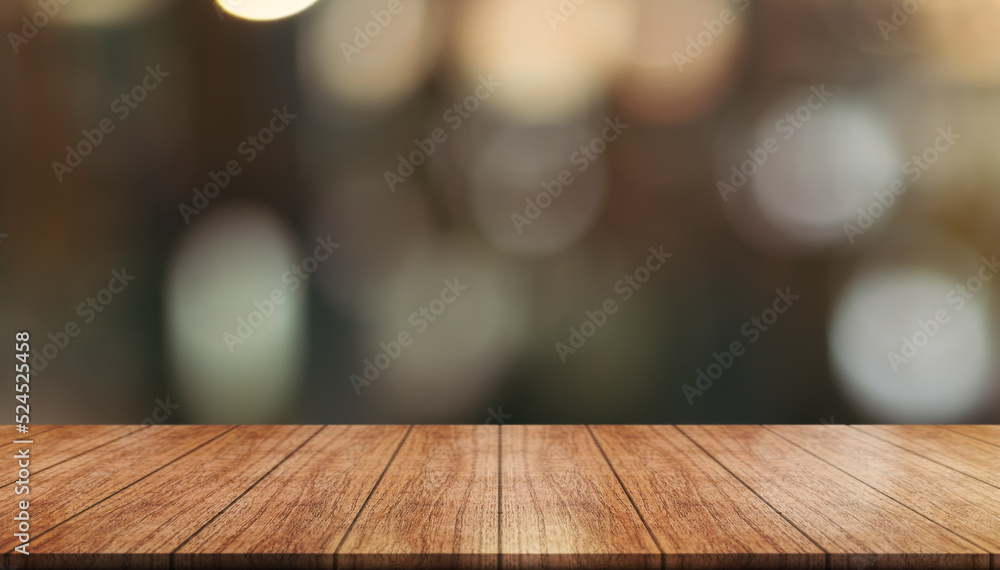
[362,238,528,421]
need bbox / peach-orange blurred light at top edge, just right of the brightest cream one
[619,0,749,123]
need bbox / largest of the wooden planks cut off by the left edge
[0,426,229,552]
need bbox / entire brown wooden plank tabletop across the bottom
[7,425,1000,570]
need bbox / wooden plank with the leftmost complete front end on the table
[16,426,320,568]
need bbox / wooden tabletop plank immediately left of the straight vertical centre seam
[336,426,499,568]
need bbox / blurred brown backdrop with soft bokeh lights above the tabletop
[0,0,1000,423]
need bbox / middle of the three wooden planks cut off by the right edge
[851,425,1000,486]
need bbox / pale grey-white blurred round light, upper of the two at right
[752,95,903,247]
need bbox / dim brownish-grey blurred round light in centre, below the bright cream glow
[470,123,614,255]
